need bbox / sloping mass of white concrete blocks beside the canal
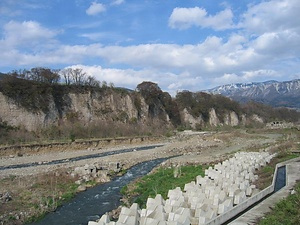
[88,152,273,225]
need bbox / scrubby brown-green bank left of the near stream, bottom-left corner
[0,170,77,225]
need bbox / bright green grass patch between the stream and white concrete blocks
[125,166,204,207]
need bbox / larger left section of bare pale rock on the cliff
[0,91,166,131]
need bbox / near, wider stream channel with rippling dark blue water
[31,158,167,225]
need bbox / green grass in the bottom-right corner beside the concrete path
[259,181,300,225]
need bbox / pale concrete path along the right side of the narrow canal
[229,157,300,225]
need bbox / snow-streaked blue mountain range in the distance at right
[206,79,300,109]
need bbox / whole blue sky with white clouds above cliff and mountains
[0,0,300,95]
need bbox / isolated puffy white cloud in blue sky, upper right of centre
[169,7,233,30]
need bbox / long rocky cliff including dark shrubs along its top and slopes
[0,79,292,133]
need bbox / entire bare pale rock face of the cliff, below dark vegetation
[0,86,263,131]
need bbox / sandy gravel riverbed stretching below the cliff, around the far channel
[0,131,280,178]
